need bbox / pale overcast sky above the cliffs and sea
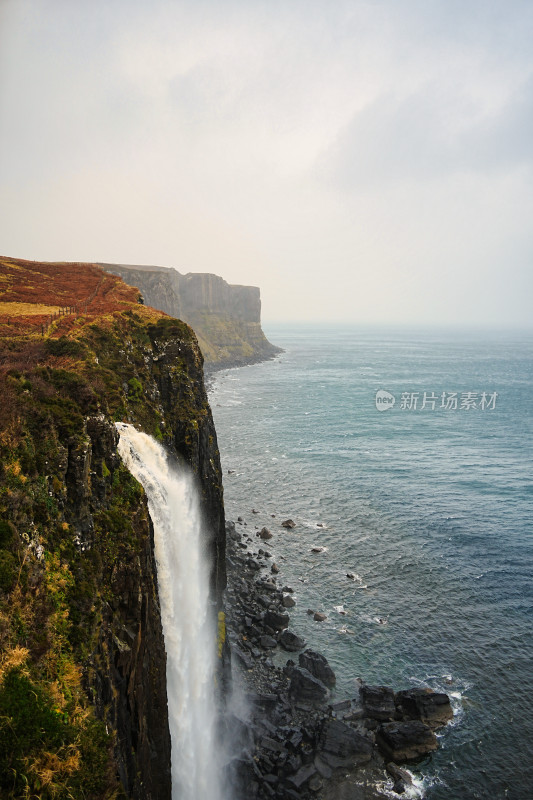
[0,0,533,327]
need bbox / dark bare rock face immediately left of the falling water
[65,414,171,800]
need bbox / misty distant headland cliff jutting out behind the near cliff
[100,264,280,369]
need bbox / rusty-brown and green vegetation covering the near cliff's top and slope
[0,260,212,800]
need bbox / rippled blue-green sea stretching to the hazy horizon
[210,324,533,800]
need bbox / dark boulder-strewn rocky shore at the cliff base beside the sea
[222,517,453,800]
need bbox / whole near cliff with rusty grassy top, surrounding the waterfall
[0,258,225,800]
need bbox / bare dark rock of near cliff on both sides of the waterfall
[83,320,226,800]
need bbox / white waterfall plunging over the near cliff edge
[117,423,221,800]
